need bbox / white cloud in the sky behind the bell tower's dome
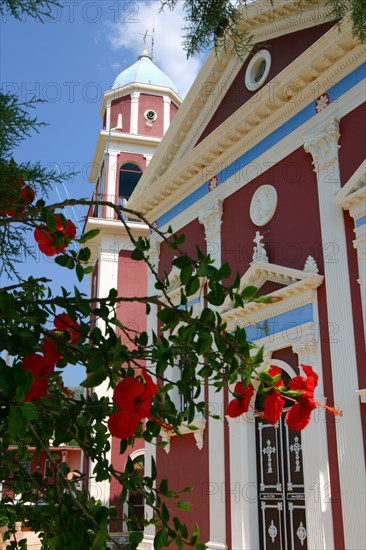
[107,0,203,97]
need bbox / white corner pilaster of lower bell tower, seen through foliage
[89,248,118,506]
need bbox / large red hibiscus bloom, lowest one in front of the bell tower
[108,372,158,439]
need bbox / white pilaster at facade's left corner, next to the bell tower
[138,237,160,550]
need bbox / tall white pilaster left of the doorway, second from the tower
[198,201,227,550]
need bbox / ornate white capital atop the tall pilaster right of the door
[304,118,340,172]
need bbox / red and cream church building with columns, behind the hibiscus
[88,0,366,550]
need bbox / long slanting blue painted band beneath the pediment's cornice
[157,63,366,227]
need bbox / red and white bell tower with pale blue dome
[84,48,182,533]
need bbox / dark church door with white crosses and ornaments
[256,414,307,550]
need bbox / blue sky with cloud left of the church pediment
[0,0,201,385]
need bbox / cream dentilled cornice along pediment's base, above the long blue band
[130,21,364,224]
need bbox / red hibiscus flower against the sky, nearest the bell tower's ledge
[34,214,76,256]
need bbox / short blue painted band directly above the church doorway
[246,304,313,344]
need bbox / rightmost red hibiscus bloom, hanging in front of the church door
[286,365,318,432]
